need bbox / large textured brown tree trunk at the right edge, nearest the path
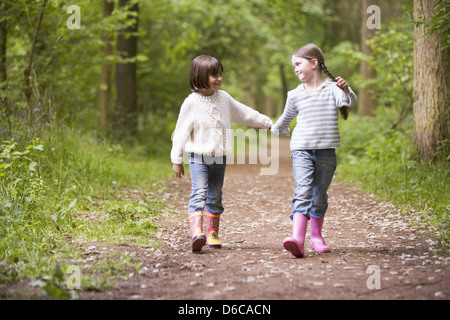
[414,0,450,161]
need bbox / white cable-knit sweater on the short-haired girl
[170,90,272,164]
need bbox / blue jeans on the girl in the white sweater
[189,153,226,214]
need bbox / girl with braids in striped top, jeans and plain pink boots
[271,43,356,257]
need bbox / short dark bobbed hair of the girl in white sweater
[190,55,223,92]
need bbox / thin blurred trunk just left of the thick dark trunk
[100,0,114,131]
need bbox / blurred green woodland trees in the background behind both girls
[0,0,449,160]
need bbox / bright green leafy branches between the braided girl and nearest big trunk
[334,12,414,122]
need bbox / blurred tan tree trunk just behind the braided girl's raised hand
[358,0,377,117]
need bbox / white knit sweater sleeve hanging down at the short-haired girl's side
[170,101,194,164]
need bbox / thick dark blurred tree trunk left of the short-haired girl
[114,0,139,139]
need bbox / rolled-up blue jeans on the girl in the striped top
[290,149,336,219]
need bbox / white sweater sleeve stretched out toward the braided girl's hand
[226,93,273,129]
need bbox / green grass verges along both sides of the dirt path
[0,112,450,299]
